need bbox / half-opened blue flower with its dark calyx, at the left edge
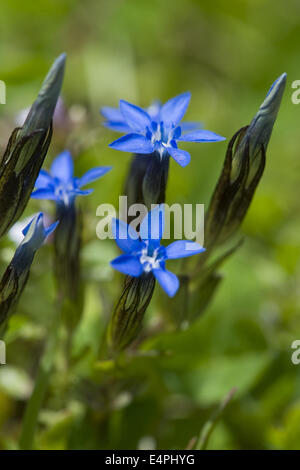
[0,212,58,335]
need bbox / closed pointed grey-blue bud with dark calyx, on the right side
[205,74,286,249]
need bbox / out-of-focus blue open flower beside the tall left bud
[31,150,111,206]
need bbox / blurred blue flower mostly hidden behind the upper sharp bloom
[100,100,202,133]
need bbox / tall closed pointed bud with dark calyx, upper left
[0,54,66,236]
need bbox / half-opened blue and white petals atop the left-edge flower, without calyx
[11,212,58,273]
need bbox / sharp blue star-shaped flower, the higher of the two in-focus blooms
[106,92,224,167]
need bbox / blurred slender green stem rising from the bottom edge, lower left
[19,310,60,450]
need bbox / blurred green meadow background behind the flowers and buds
[0,0,300,449]
